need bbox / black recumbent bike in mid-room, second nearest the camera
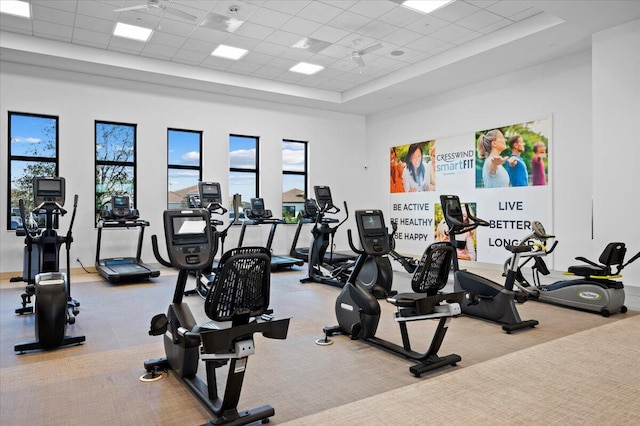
[316,210,463,377]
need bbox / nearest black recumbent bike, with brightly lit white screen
[144,209,289,425]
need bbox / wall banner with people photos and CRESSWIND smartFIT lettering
[389,118,553,266]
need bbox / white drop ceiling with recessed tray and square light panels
[0,0,640,115]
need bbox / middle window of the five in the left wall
[167,129,202,209]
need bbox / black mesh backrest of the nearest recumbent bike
[204,247,271,325]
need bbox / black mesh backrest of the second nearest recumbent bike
[411,242,455,296]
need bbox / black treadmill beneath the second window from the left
[95,195,160,283]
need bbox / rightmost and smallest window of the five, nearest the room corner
[282,140,307,223]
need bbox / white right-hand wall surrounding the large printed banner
[367,41,640,285]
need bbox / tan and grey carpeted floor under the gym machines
[0,268,640,425]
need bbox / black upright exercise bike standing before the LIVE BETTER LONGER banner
[440,195,538,334]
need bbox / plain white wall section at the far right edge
[592,20,640,286]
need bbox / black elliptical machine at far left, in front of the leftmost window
[14,176,85,353]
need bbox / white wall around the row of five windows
[0,63,365,272]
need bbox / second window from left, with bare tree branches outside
[95,121,136,223]
